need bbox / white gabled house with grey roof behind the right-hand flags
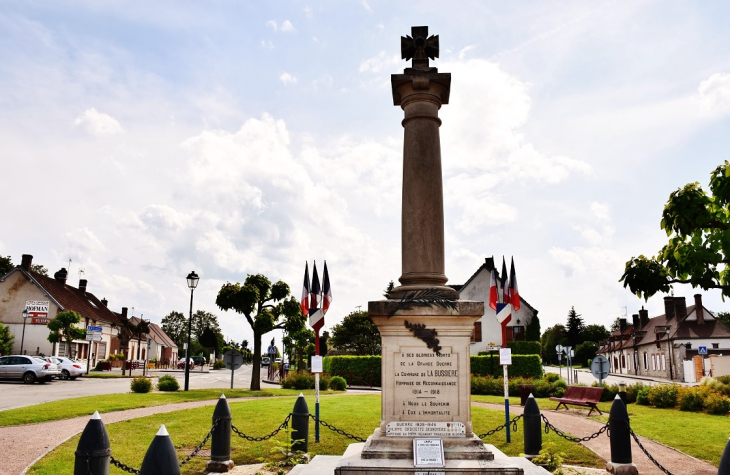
[451,257,537,355]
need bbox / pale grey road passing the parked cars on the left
[0,365,280,411]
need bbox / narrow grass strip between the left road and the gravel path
[0,389,330,426]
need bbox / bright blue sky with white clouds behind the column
[0,0,730,350]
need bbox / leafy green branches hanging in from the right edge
[619,160,730,300]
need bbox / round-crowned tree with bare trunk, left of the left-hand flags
[215,274,305,391]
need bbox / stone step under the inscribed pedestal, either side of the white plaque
[362,429,494,461]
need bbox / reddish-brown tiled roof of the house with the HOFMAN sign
[23,268,119,325]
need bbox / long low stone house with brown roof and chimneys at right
[598,294,730,382]
